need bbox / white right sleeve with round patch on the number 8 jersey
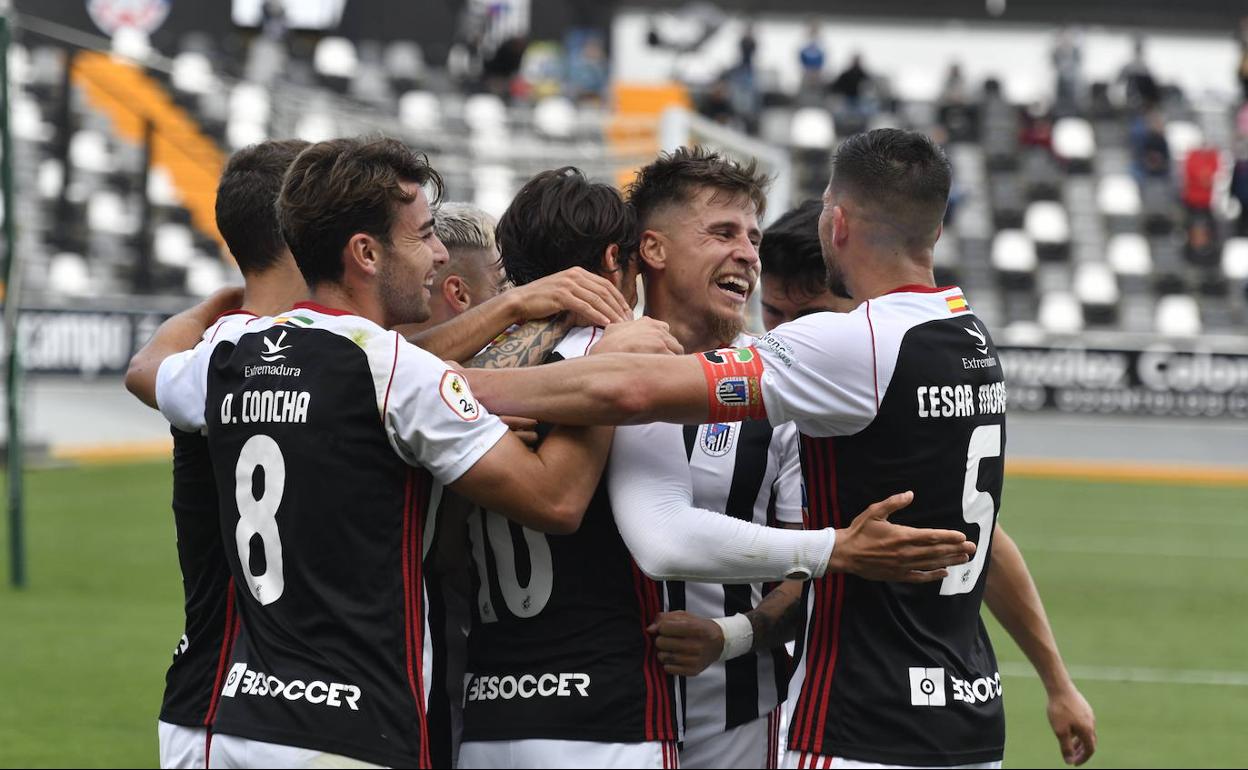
[369,333,507,484]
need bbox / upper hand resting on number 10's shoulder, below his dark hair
[503,267,633,326]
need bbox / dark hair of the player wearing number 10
[494,166,638,286]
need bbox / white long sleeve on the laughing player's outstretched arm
[608,423,836,583]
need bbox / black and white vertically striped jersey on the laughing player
[610,334,802,744]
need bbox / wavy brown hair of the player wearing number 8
[277,139,442,286]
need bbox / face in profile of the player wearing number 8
[378,182,448,326]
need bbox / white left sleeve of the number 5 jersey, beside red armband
[758,303,896,437]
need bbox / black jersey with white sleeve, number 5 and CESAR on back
[758,286,1006,765]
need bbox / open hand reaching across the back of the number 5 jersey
[827,492,975,583]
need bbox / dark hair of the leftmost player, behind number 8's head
[216,139,310,276]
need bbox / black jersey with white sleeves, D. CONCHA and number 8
[156,303,507,768]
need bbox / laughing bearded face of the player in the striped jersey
[661,188,763,343]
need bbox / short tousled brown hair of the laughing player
[626,146,771,228]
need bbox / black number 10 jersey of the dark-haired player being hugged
[463,327,679,743]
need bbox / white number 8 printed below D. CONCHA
[235,434,286,604]
